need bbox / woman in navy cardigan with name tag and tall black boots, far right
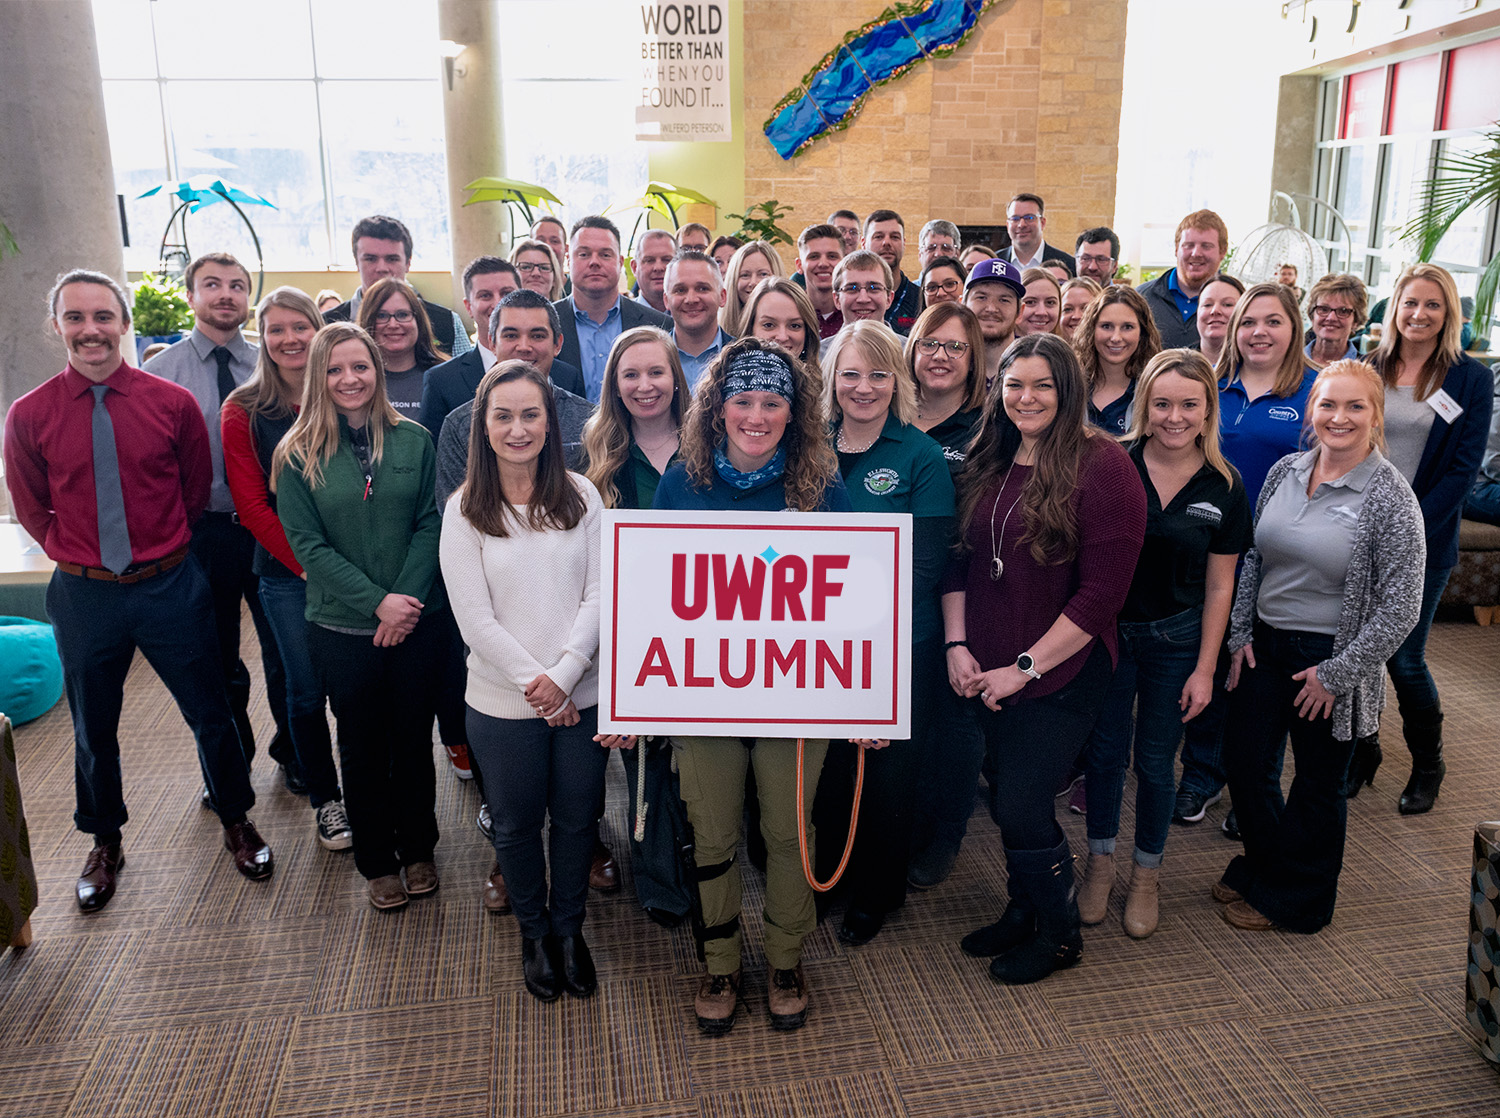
[1368,264,1494,815]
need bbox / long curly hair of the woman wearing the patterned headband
[681,338,839,512]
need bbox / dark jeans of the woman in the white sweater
[468,707,609,939]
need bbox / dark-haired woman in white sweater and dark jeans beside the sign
[441,360,608,1001]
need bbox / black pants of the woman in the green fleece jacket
[308,617,438,878]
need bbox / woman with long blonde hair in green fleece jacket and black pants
[272,323,446,909]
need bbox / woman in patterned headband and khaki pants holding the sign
[656,338,851,1035]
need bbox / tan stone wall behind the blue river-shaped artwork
[744,0,1125,258]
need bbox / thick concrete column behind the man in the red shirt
[0,0,125,411]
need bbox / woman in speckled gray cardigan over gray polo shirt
[1212,360,1427,932]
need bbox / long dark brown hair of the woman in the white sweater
[459,360,588,539]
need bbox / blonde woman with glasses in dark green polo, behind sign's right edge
[813,320,954,944]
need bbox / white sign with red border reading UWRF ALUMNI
[599,509,912,740]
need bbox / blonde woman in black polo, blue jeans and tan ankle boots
[1079,350,1251,939]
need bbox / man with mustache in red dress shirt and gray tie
[5,269,275,912]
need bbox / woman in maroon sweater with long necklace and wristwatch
[942,333,1146,984]
